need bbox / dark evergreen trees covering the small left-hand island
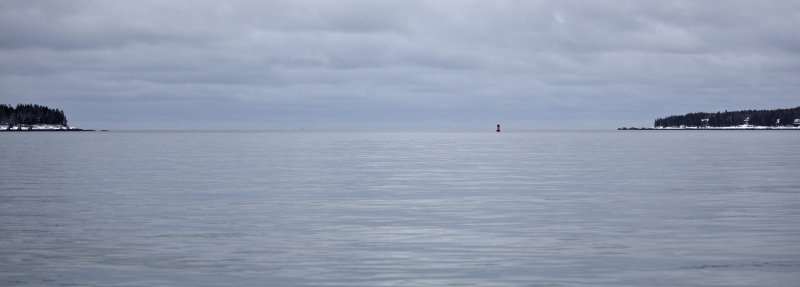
[0,104,67,126]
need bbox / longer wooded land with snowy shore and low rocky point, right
[619,107,800,130]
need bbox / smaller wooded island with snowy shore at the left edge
[0,104,87,131]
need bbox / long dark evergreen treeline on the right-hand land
[653,107,800,127]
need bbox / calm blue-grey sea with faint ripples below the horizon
[0,131,800,286]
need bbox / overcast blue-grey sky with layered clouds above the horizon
[0,0,800,130]
